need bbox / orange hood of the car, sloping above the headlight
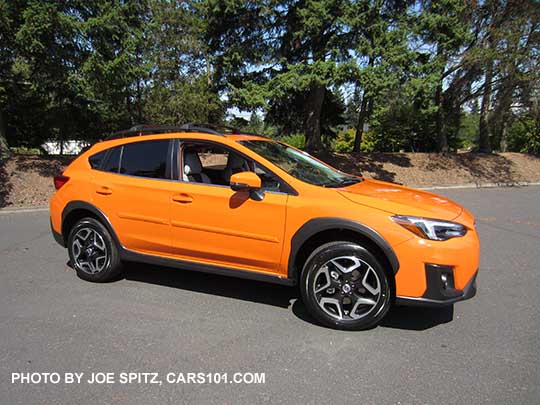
[337,179,463,221]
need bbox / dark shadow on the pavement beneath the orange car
[123,263,454,331]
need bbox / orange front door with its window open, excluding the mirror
[171,142,288,272]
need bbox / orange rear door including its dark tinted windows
[93,139,175,254]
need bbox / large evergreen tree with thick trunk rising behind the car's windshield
[208,0,350,150]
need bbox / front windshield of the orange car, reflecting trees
[239,140,362,187]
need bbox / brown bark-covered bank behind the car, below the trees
[0,153,540,208]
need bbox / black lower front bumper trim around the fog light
[396,264,478,307]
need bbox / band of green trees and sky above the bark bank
[0,0,540,153]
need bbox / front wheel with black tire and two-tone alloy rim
[300,241,392,330]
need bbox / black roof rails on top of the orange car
[105,122,269,141]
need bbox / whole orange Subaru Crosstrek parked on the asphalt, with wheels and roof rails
[50,124,479,329]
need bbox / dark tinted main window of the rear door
[120,139,169,179]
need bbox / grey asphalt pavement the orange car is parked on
[0,186,540,404]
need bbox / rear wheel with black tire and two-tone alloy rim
[67,218,122,283]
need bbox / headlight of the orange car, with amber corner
[392,215,467,240]
